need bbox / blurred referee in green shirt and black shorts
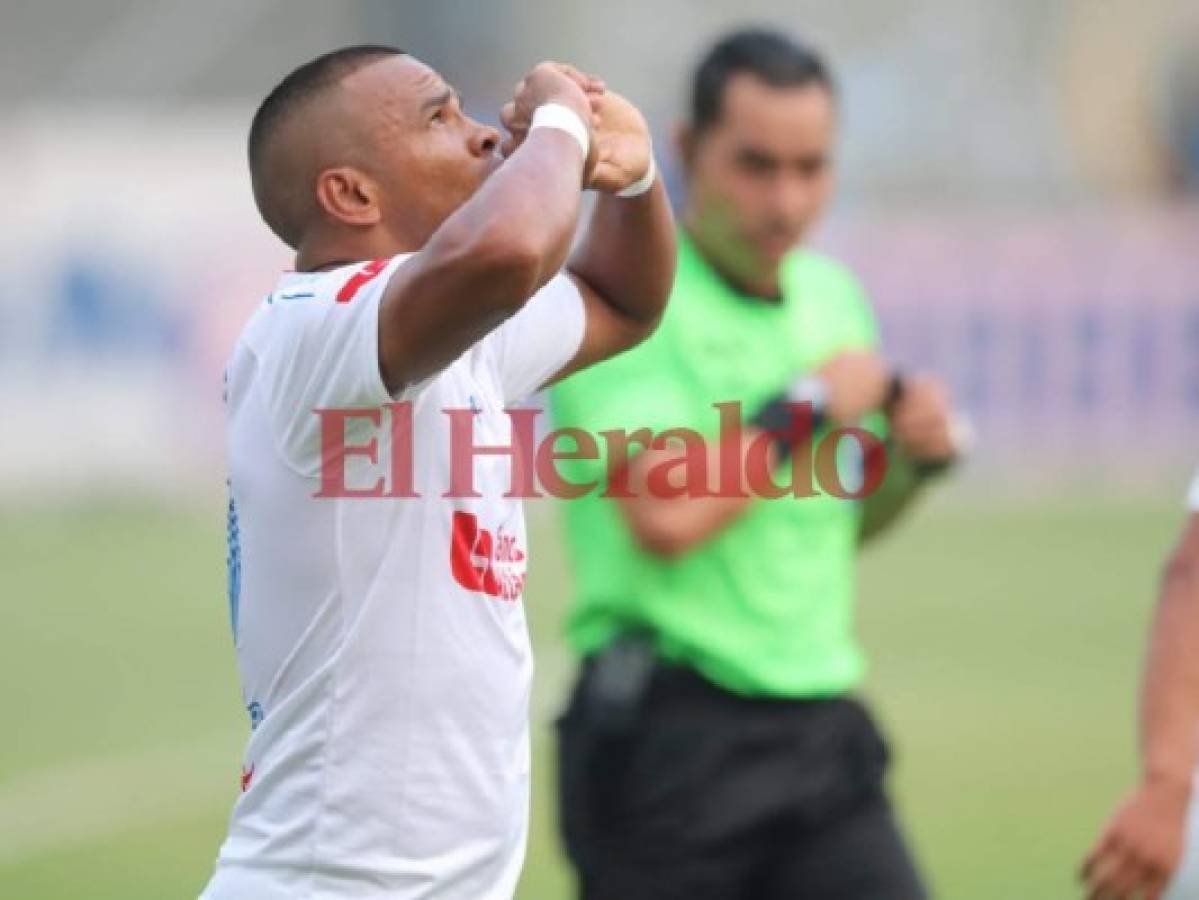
[553,30,954,900]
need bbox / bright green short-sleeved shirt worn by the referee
[552,234,878,697]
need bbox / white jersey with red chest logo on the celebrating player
[203,256,584,900]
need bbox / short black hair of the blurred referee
[691,28,836,132]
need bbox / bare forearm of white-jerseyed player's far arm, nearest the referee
[568,179,675,338]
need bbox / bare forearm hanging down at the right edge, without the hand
[1141,534,1199,790]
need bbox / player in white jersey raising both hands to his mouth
[204,47,675,900]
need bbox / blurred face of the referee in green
[687,79,836,282]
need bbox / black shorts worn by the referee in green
[559,664,926,900]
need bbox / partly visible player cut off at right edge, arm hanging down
[1083,476,1199,900]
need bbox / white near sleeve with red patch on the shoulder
[247,255,432,473]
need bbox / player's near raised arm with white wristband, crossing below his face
[379,62,591,389]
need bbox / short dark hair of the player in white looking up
[247,44,404,247]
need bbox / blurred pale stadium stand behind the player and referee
[0,0,1199,493]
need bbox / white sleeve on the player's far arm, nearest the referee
[484,273,586,403]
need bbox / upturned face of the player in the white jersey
[354,56,500,238]
